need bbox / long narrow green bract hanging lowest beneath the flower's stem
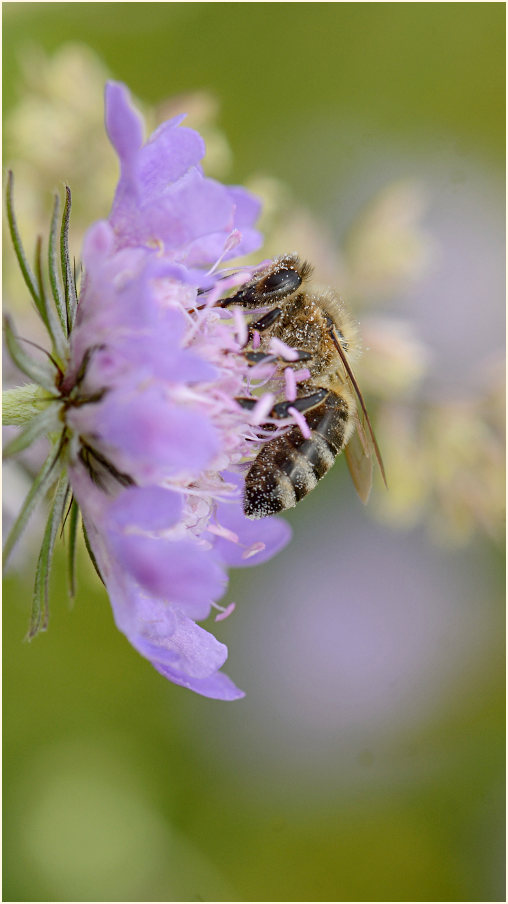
[27,474,69,640]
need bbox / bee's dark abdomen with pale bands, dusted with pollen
[244,392,348,518]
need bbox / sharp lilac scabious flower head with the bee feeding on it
[3,82,289,700]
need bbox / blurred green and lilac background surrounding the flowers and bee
[3,3,505,901]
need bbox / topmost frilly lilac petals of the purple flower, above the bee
[106,82,261,266]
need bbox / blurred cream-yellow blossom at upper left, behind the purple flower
[4,44,116,258]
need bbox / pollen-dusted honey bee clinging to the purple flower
[220,254,386,518]
